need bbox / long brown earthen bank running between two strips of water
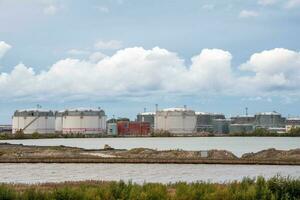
[0,143,300,166]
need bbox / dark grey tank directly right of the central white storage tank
[195,112,225,133]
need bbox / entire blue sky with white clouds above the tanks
[0,0,300,124]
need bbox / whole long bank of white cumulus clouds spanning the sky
[0,47,300,99]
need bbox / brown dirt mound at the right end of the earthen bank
[241,148,300,160]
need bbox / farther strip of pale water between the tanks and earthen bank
[1,137,300,156]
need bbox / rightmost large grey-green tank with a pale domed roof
[254,111,286,129]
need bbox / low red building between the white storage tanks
[117,121,150,136]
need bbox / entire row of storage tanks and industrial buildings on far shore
[6,105,300,137]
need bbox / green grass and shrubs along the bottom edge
[0,177,300,200]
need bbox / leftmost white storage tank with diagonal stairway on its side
[12,109,55,134]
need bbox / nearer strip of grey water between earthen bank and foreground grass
[0,164,300,183]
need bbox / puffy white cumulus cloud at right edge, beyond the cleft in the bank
[240,48,300,93]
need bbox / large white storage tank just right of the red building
[154,108,197,135]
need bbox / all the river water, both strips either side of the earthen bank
[0,137,300,183]
